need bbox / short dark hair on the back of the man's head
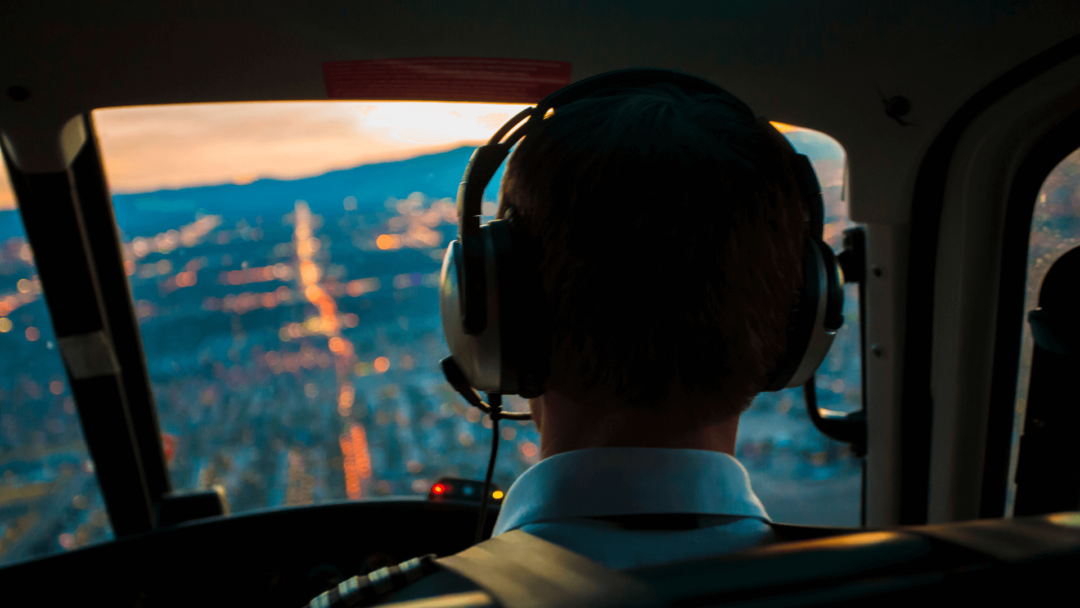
[500,85,805,422]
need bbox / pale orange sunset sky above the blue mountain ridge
[0,102,842,210]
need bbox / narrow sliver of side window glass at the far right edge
[1005,149,1080,516]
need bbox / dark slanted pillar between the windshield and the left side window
[2,113,171,538]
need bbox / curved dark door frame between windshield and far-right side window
[905,38,1080,524]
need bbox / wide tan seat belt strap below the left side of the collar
[435,530,656,608]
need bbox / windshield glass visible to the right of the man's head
[735,124,862,526]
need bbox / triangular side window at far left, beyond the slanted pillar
[0,163,112,566]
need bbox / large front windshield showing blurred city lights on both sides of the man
[93,102,860,525]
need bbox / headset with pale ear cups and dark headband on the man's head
[438,69,843,414]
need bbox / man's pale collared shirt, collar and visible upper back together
[492,447,773,568]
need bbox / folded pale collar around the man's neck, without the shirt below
[492,447,770,536]
